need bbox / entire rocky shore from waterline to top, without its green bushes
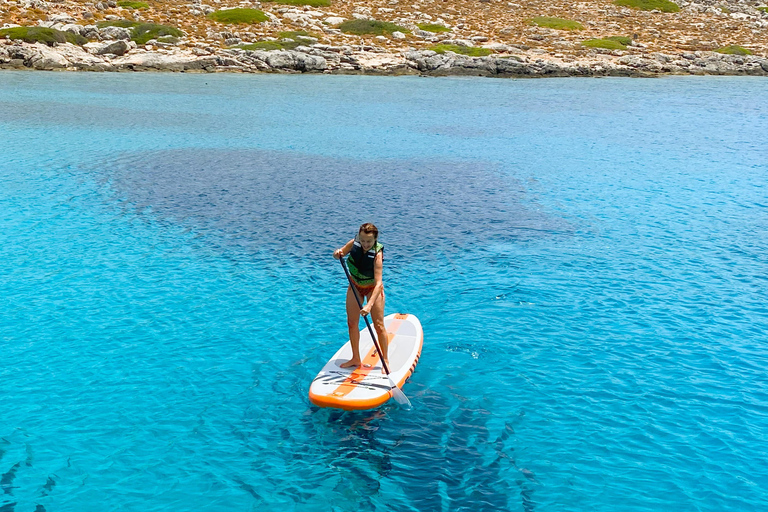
[0,0,768,77]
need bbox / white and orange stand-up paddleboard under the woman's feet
[309,313,424,411]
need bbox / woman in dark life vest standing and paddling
[333,223,389,372]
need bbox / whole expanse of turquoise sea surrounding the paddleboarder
[0,72,768,512]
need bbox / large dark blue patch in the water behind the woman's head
[90,149,569,256]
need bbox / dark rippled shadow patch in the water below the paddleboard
[234,384,539,512]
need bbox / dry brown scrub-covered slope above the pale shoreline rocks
[0,0,768,56]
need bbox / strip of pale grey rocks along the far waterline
[0,40,768,78]
